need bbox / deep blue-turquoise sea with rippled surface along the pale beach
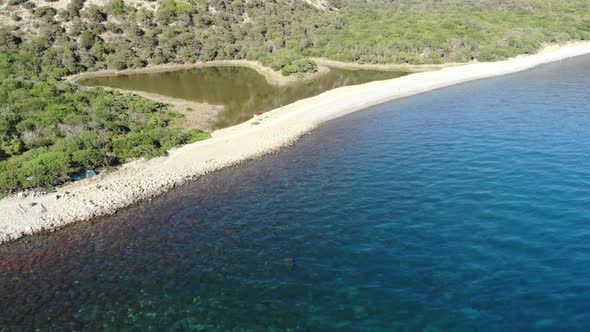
[0,57,590,331]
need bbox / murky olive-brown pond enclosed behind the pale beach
[79,67,406,128]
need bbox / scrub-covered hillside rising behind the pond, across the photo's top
[4,0,590,75]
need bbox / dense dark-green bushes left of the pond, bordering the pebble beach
[0,52,208,194]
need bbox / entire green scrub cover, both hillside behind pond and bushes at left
[0,0,590,194]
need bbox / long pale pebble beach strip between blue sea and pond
[0,42,590,242]
